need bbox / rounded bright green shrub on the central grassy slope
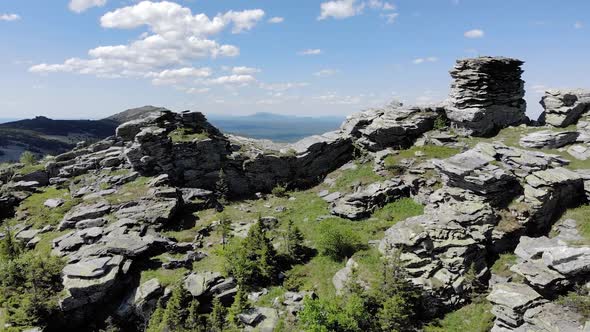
[318,221,362,260]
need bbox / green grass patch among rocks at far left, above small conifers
[17,187,80,228]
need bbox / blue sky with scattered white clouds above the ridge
[0,0,590,119]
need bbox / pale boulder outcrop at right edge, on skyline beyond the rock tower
[539,89,590,127]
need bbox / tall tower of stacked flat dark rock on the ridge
[447,57,526,136]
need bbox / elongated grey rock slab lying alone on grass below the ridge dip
[331,179,410,220]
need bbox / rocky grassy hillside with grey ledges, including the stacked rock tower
[0,58,590,331]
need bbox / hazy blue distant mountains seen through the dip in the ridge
[207,112,344,142]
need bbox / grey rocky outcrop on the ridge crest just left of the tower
[340,102,444,151]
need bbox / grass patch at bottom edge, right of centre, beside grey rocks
[424,298,494,332]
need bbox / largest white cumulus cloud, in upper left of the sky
[29,1,264,82]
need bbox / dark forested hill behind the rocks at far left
[0,106,163,162]
